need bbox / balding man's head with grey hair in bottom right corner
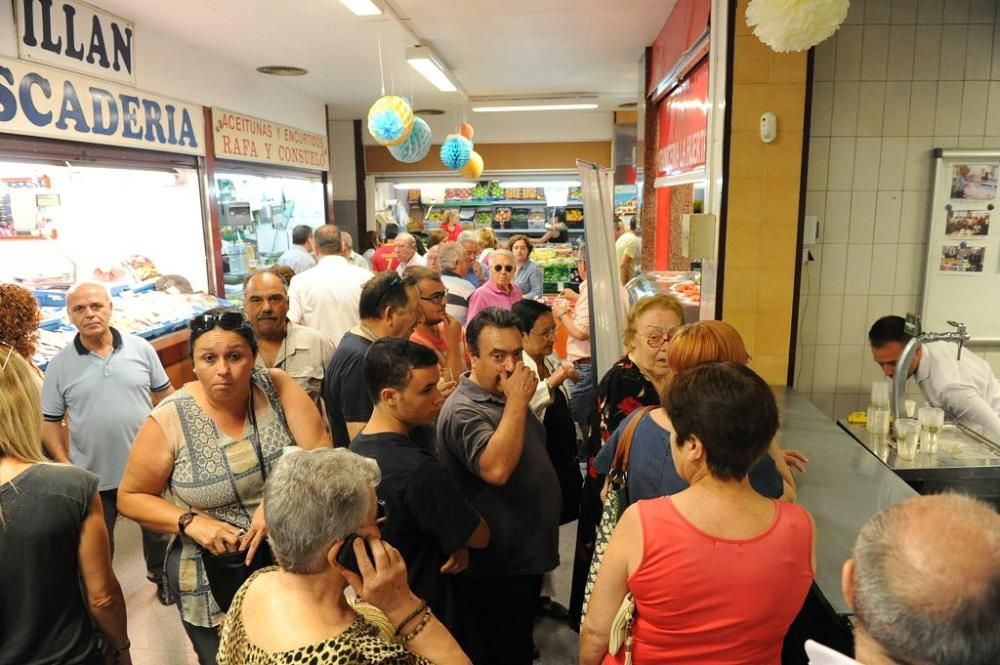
[844,494,1000,665]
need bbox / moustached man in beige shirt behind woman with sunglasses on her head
[243,270,333,408]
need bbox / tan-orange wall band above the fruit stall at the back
[365,141,611,173]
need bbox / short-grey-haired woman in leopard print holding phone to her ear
[219,448,468,665]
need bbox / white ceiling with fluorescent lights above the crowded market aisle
[91,0,676,118]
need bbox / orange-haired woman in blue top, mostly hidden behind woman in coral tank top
[594,321,795,505]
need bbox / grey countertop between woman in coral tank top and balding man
[774,387,917,615]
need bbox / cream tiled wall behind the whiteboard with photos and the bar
[795,0,1000,416]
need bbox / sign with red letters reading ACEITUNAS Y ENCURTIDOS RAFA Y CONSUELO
[212,108,330,171]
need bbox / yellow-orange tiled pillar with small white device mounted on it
[722,0,806,385]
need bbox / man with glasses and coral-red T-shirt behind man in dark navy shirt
[406,266,465,390]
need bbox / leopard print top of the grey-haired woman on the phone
[218,567,431,665]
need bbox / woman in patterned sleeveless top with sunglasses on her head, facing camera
[118,308,330,665]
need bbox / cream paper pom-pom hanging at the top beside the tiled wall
[747,0,851,53]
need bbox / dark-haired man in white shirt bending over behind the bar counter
[868,316,1000,437]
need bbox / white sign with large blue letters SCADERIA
[0,58,205,155]
